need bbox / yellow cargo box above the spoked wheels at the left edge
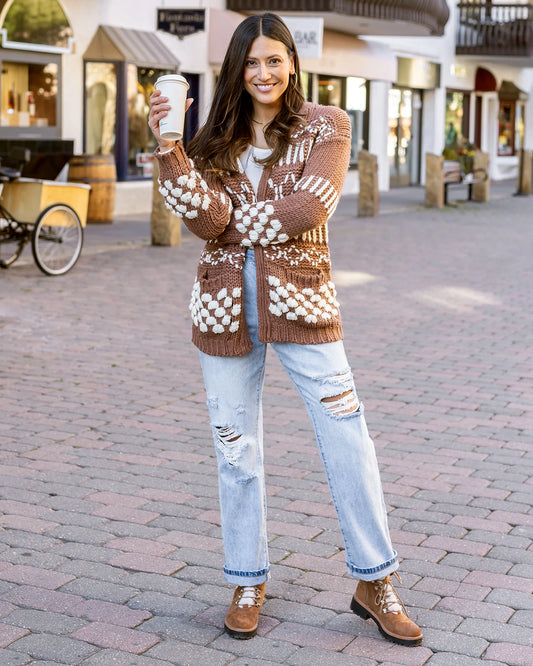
[2,178,91,226]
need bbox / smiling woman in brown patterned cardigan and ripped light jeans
[149,13,422,645]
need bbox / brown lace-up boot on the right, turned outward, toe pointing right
[351,573,422,646]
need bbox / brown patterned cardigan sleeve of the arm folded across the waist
[218,108,351,247]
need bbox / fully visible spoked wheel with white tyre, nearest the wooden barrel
[31,204,83,275]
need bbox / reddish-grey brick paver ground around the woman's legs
[0,179,533,666]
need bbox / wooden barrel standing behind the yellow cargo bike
[68,155,117,224]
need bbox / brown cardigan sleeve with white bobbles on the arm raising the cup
[154,141,233,240]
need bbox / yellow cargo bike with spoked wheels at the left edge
[0,155,90,275]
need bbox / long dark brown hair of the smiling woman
[187,13,305,173]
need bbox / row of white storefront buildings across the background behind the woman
[0,0,533,214]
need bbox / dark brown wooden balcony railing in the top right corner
[455,0,533,58]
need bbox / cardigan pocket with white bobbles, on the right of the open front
[266,266,340,328]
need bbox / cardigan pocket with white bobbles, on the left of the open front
[189,268,242,334]
